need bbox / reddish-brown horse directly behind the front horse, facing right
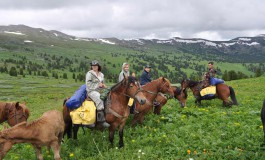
[132,77,174,126]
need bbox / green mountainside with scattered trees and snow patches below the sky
[0,25,265,83]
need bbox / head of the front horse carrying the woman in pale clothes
[122,76,146,105]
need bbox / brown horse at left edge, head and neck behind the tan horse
[0,102,29,127]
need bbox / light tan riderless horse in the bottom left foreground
[0,110,64,160]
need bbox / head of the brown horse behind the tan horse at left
[5,102,29,126]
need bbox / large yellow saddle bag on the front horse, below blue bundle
[70,100,96,125]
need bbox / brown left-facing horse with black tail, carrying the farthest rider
[181,79,238,107]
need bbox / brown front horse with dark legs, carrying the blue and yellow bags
[63,76,146,148]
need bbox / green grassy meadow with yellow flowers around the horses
[0,74,265,160]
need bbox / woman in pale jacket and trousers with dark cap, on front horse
[86,60,110,128]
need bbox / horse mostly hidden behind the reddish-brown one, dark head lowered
[154,86,188,115]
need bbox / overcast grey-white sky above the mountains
[0,0,265,41]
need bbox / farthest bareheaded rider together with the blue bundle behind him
[203,62,224,88]
